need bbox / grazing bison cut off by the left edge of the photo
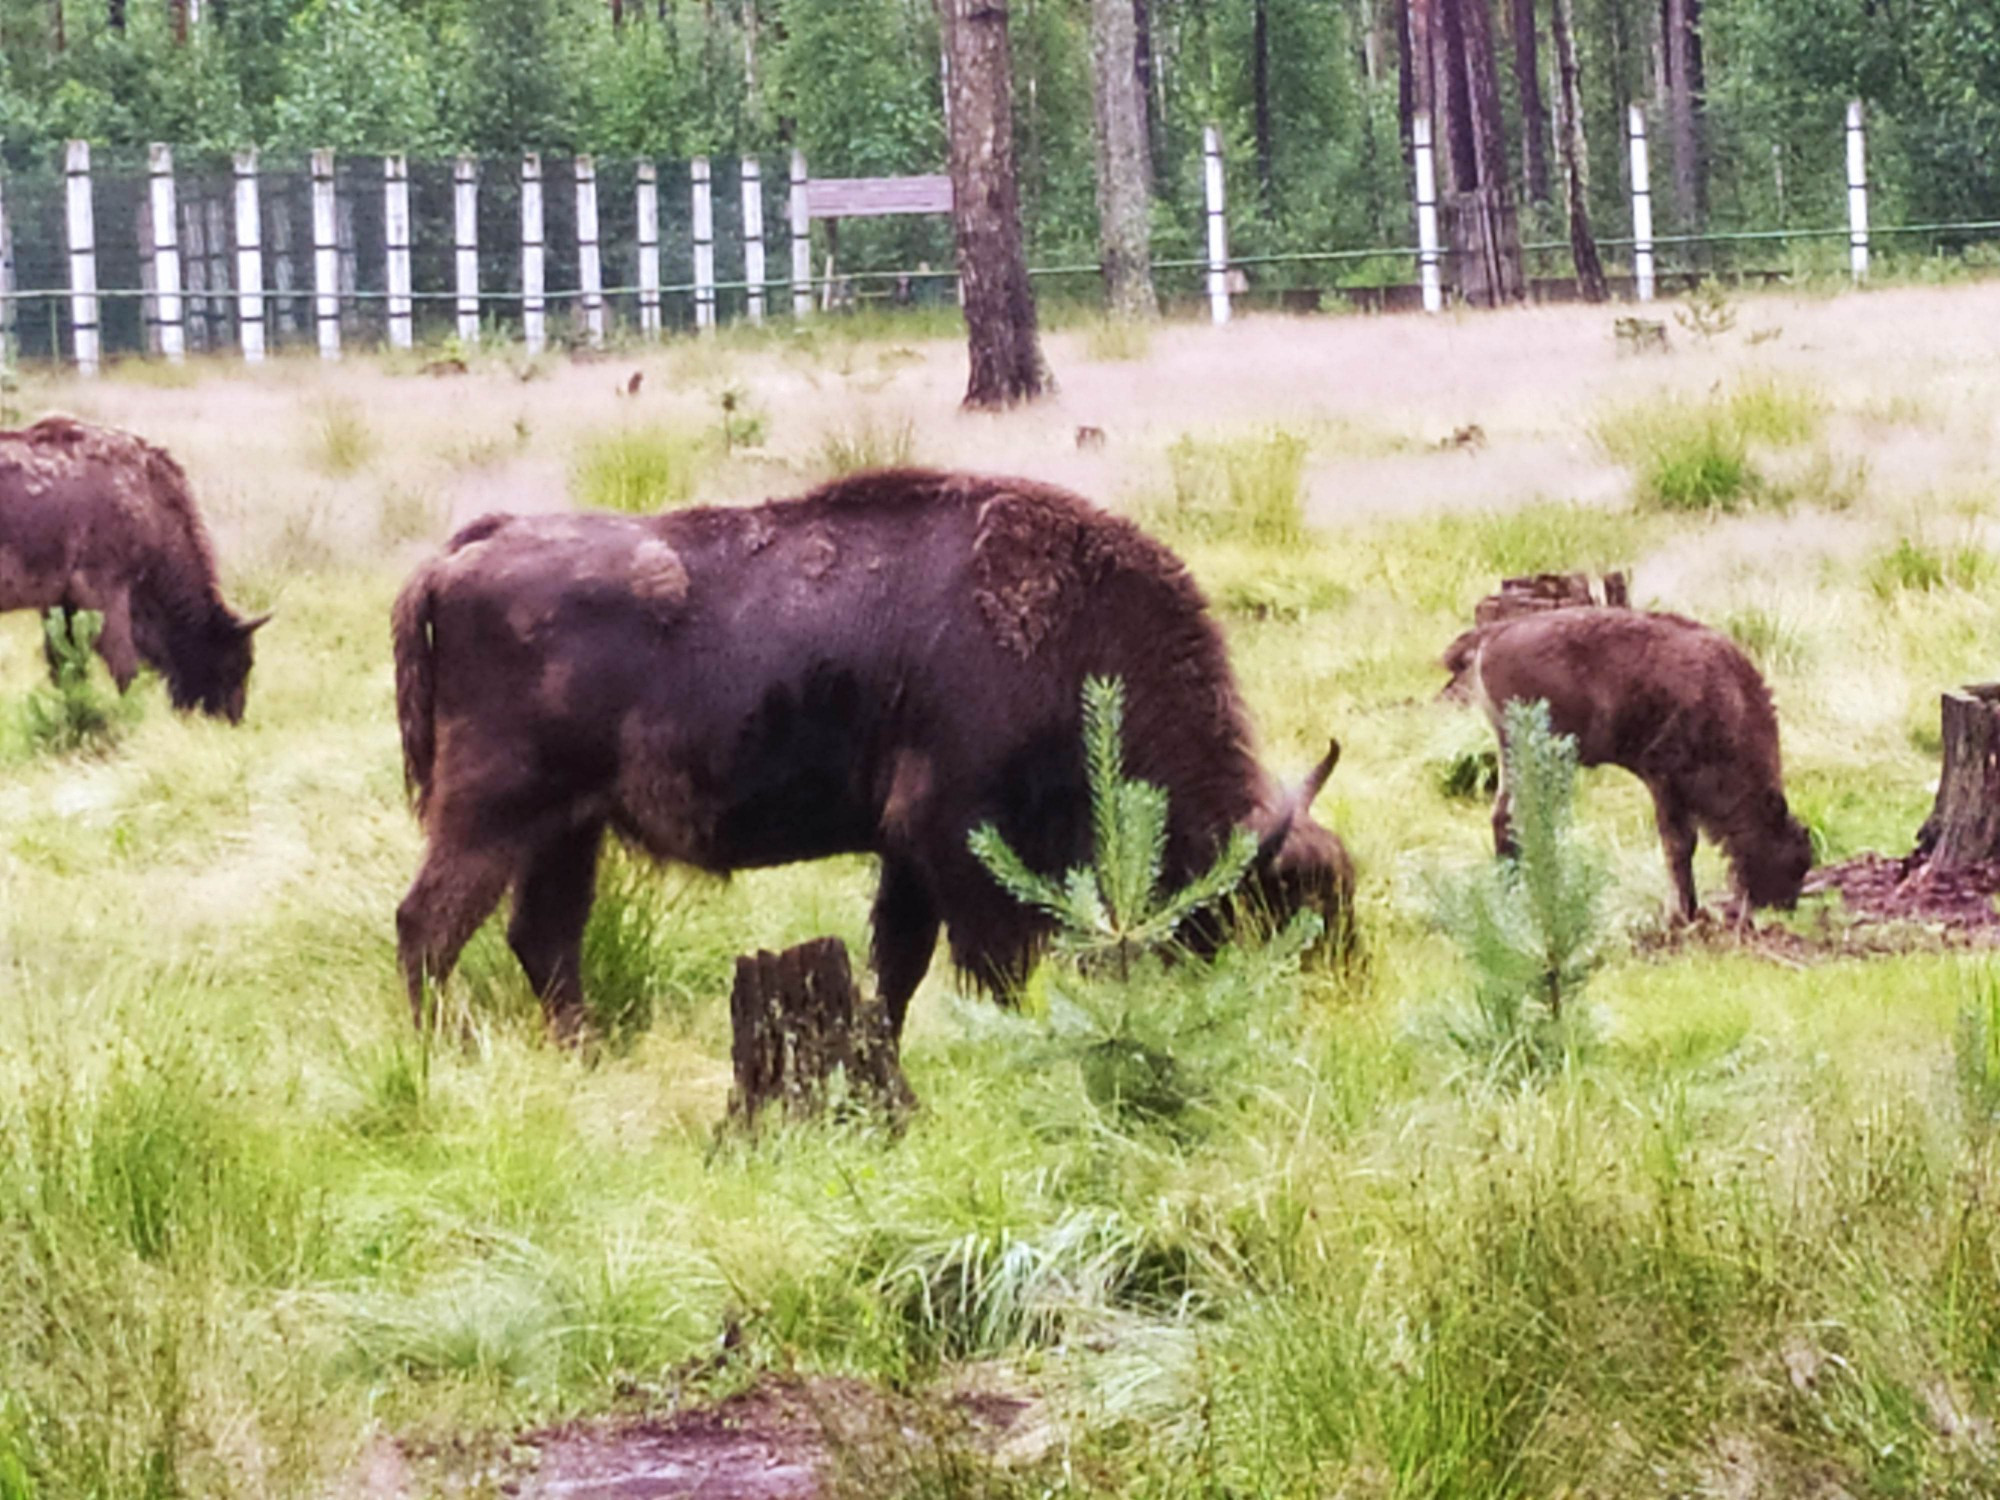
[0,416,270,724]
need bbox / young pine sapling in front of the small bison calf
[1438,702,1606,1078]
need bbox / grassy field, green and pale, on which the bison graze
[0,288,2000,1500]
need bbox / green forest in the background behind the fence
[0,0,2000,280]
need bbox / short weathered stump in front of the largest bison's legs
[730,938,916,1124]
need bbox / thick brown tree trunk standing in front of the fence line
[938,0,1048,410]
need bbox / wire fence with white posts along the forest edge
[0,98,2000,366]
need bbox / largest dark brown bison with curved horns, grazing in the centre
[394,470,1352,1034]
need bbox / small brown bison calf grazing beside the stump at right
[1442,608,1812,920]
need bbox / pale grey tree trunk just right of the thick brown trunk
[1090,0,1160,318]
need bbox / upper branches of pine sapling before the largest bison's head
[970,678,1256,978]
